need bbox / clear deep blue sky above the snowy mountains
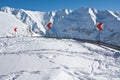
[0,0,120,11]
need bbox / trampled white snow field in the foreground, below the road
[0,37,120,80]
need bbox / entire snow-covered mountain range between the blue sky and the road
[0,7,120,46]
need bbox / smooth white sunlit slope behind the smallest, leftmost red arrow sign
[0,11,32,37]
